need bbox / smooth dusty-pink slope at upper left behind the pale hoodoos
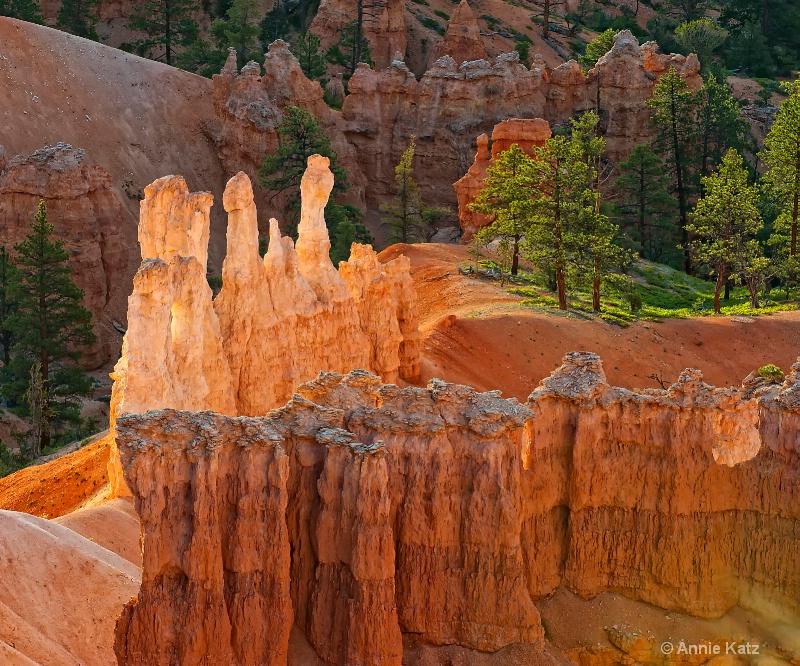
[0,17,233,316]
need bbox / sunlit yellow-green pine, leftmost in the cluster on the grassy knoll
[469,143,540,275]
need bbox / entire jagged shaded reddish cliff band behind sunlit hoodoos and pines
[211,31,702,220]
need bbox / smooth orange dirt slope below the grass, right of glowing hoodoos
[381,244,800,400]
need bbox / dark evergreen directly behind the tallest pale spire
[258,106,372,250]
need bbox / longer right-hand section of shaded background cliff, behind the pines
[342,31,702,211]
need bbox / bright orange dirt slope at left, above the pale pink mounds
[0,436,110,518]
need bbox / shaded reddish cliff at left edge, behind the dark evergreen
[0,143,128,368]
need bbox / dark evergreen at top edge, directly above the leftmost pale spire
[128,0,199,65]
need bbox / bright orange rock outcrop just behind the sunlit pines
[453,118,551,242]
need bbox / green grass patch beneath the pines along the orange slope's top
[472,261,800,326]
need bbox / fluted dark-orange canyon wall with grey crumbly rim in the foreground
[116,352,800,666]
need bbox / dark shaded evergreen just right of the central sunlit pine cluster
[614,146,679,263]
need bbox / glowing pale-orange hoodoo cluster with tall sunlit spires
[111,156,419,490]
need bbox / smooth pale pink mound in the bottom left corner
[0,511,141,666]
